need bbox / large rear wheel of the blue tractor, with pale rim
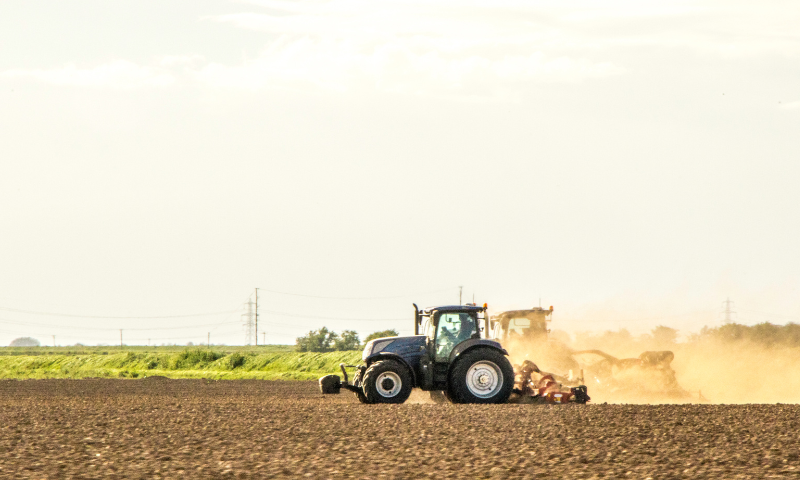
[447,348,514,403]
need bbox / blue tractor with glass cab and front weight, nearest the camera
[319,304,514,403]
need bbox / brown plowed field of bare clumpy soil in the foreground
[0,379,800,479]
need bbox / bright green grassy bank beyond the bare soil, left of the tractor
[0,347,361,380]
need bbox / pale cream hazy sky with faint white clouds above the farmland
[0,0,800,345]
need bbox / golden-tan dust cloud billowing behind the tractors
[504,324,800,404]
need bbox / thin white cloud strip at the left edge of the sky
[0,60,176,89]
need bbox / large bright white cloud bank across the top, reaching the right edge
[198,0,800,97]
